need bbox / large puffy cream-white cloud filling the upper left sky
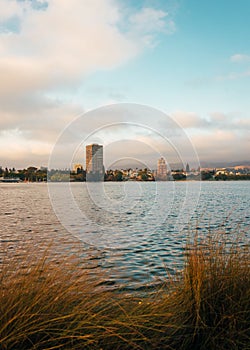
[0,0,174,93]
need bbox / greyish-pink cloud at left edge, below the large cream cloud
[0,94,83,142]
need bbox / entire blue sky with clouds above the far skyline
[0,0,250,168]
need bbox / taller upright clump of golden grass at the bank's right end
[166,236,250,349]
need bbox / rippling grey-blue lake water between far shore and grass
[0,181,250,290]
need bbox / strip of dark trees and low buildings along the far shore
[0,166,250,183]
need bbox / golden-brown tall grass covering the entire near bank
[0,235,250,350]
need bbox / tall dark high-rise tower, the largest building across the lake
[86,143,104,181]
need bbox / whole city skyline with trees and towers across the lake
[0,161,250,183]
